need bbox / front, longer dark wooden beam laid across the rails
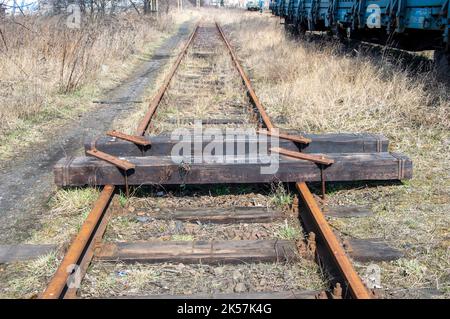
[54,153,412,187]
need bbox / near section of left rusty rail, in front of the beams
[41,185,115,299]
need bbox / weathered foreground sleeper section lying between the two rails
[96,240,297,264]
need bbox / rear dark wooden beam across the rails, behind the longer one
[85,131,389,156]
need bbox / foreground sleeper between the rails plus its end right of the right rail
[95,238,403,264]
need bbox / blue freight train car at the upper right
[270,0,450,72]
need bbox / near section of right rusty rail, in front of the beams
[296,182,371,299]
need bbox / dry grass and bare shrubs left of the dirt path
[0,13,179,158]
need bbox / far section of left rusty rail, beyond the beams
[136,24,199,136]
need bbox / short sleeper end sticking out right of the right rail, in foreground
[345,238,403,262]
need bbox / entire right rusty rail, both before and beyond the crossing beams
[216,22,371,299]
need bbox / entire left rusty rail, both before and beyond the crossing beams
[39,23,199,299]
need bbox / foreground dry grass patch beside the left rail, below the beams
[0,188,100,298]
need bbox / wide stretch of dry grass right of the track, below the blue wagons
[215,10,450,297]
